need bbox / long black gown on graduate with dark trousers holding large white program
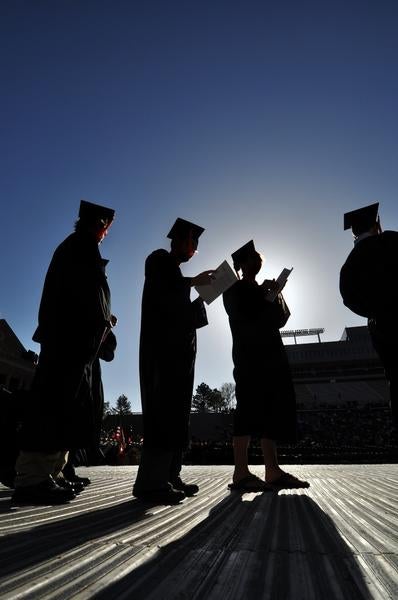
[140,249,204,450]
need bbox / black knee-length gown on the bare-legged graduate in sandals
[223,279,296,441]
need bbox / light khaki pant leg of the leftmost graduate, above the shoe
[15,450,66,488]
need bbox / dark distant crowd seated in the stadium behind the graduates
[101,406,398,465]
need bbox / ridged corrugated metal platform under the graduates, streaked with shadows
[0,465,398,600]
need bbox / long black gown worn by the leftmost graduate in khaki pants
[20,232,111,451]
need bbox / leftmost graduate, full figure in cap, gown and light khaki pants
[13,200,115,504]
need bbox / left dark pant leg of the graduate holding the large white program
[134,446,173,492]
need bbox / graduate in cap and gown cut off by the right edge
[340,202,398,424]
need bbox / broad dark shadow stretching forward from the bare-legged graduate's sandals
[95,493,372,600]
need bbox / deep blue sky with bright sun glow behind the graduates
[0,0,398,410]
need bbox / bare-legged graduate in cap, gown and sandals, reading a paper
[223,240,308,491]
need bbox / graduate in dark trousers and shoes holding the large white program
[133,219,215,503]
